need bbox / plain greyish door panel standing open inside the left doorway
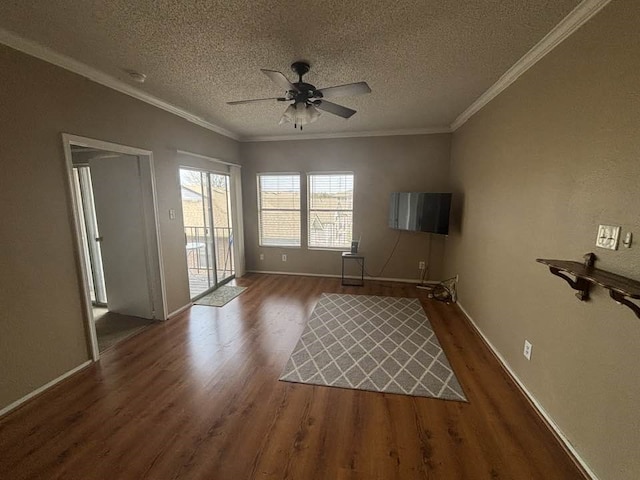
[89,155,154,319]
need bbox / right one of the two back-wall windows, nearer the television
[308,173,353,248]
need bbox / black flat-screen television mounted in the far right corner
[389,192,451,235]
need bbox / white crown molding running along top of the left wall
[0,28,240,140]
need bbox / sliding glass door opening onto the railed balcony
[180,167,235,300]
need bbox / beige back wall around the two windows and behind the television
[240,134,450,279]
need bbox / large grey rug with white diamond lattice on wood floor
[280,293,466,401]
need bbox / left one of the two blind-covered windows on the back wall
[258,173,300,247]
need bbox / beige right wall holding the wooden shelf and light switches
[446,0,640,480]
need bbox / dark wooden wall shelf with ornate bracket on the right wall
[536,253,640,318]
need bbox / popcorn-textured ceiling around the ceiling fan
[0,0,580,138]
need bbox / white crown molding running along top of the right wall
[451,0,611,132]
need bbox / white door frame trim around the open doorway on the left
[62,133,167,361]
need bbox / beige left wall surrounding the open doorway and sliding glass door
[0,45,239,409]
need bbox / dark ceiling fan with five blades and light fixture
[227,62,371,130]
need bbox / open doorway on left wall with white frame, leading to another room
[63,135,166,360]
